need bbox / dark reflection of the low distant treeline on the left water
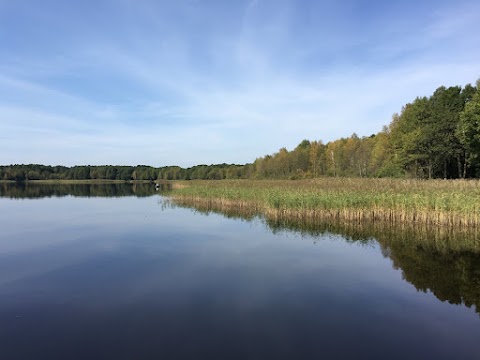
[0,183,170,199]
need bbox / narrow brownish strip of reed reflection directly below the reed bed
[170,195,480,252]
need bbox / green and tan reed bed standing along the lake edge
[172,178,480,227]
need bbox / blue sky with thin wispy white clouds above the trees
[0,0,480,167]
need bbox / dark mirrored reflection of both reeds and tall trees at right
[171,201,480,315]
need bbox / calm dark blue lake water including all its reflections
[0,185,480,359]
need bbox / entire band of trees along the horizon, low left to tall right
[0,80,480,181]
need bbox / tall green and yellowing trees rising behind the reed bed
[253,81,480,179]
